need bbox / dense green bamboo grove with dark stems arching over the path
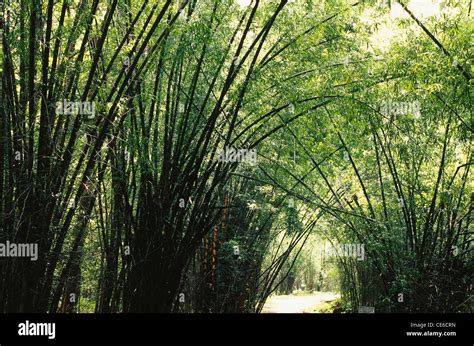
[0,0,474,313]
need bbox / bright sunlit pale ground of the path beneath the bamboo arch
[262,292,340,314]
